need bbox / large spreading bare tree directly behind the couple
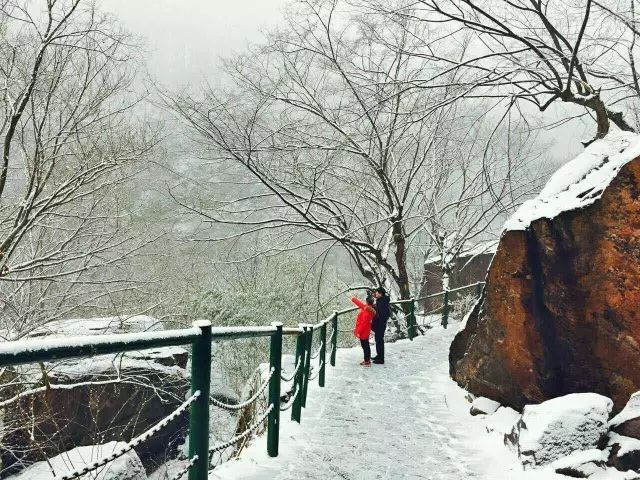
[164,1,536,298]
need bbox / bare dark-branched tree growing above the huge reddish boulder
[384,0,640,143]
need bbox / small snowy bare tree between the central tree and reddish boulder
[413,104,550,290]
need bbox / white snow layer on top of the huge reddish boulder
[504,132,640,230]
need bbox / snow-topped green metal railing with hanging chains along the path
[0,282,483,480]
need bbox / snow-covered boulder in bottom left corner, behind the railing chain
[9,442,147,480]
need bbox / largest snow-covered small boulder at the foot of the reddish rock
[515,393,613,467]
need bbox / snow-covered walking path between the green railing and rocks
[210,325,514,480]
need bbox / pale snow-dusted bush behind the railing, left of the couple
[178,255,345,394]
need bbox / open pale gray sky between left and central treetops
[100,0,286,86]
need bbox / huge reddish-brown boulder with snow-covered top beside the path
[450,133,640,410]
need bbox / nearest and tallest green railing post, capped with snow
[189,320,211,480]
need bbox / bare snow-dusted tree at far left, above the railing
[0,0,156,336]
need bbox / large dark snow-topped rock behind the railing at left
[0,317,189,471]
